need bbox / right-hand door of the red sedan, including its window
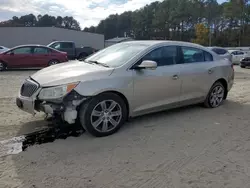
[33,47,52,67]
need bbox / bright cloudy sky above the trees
[0,0,224,28]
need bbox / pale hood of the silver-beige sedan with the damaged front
[31,61,114,87]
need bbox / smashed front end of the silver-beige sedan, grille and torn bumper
[16,79,88,124]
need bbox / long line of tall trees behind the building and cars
[0,0,250,46]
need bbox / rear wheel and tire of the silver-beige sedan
[204,82,226,108]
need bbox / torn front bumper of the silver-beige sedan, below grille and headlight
[16,87,87,124]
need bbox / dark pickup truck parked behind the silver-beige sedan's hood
[48,41,98,60]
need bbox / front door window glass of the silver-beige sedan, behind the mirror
[142,46,177,66]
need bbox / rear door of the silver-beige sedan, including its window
[180,46,215,104]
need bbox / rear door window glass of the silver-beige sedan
[181,47,205,63]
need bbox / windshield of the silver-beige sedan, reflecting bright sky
[85,43,149,67]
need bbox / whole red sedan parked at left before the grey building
[0,45,68,71]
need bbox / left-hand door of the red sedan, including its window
[3,47,32,68]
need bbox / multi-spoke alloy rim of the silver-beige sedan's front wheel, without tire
[90,100,122,132]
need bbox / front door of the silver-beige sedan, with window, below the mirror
[133,46,181,115]
